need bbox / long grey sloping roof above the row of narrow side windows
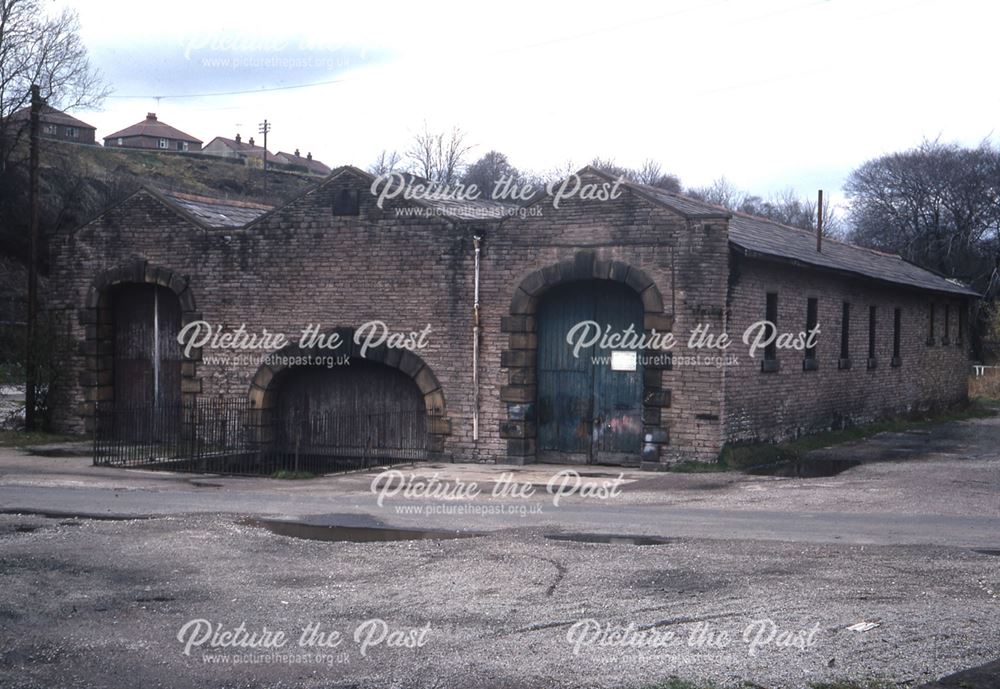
[729,213,979,296]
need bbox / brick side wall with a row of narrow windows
[725,257,969,441]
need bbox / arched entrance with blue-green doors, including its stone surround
[500,250,674,464]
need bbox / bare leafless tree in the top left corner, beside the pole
[0,0,108,169]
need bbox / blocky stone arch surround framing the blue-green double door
[500,251,674,464]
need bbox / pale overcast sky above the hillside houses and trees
[60,0,1000,201]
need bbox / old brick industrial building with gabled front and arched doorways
[48,167,976,468]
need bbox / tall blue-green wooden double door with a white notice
[537,281,643,464]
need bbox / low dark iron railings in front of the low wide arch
[94,398,428,476]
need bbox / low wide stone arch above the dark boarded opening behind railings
[249,328,451,453]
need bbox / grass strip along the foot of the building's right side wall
[714,399,1000,472]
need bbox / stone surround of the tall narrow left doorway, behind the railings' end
[78,259,201,432]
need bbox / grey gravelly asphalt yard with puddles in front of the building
[0,419,1000,687]
